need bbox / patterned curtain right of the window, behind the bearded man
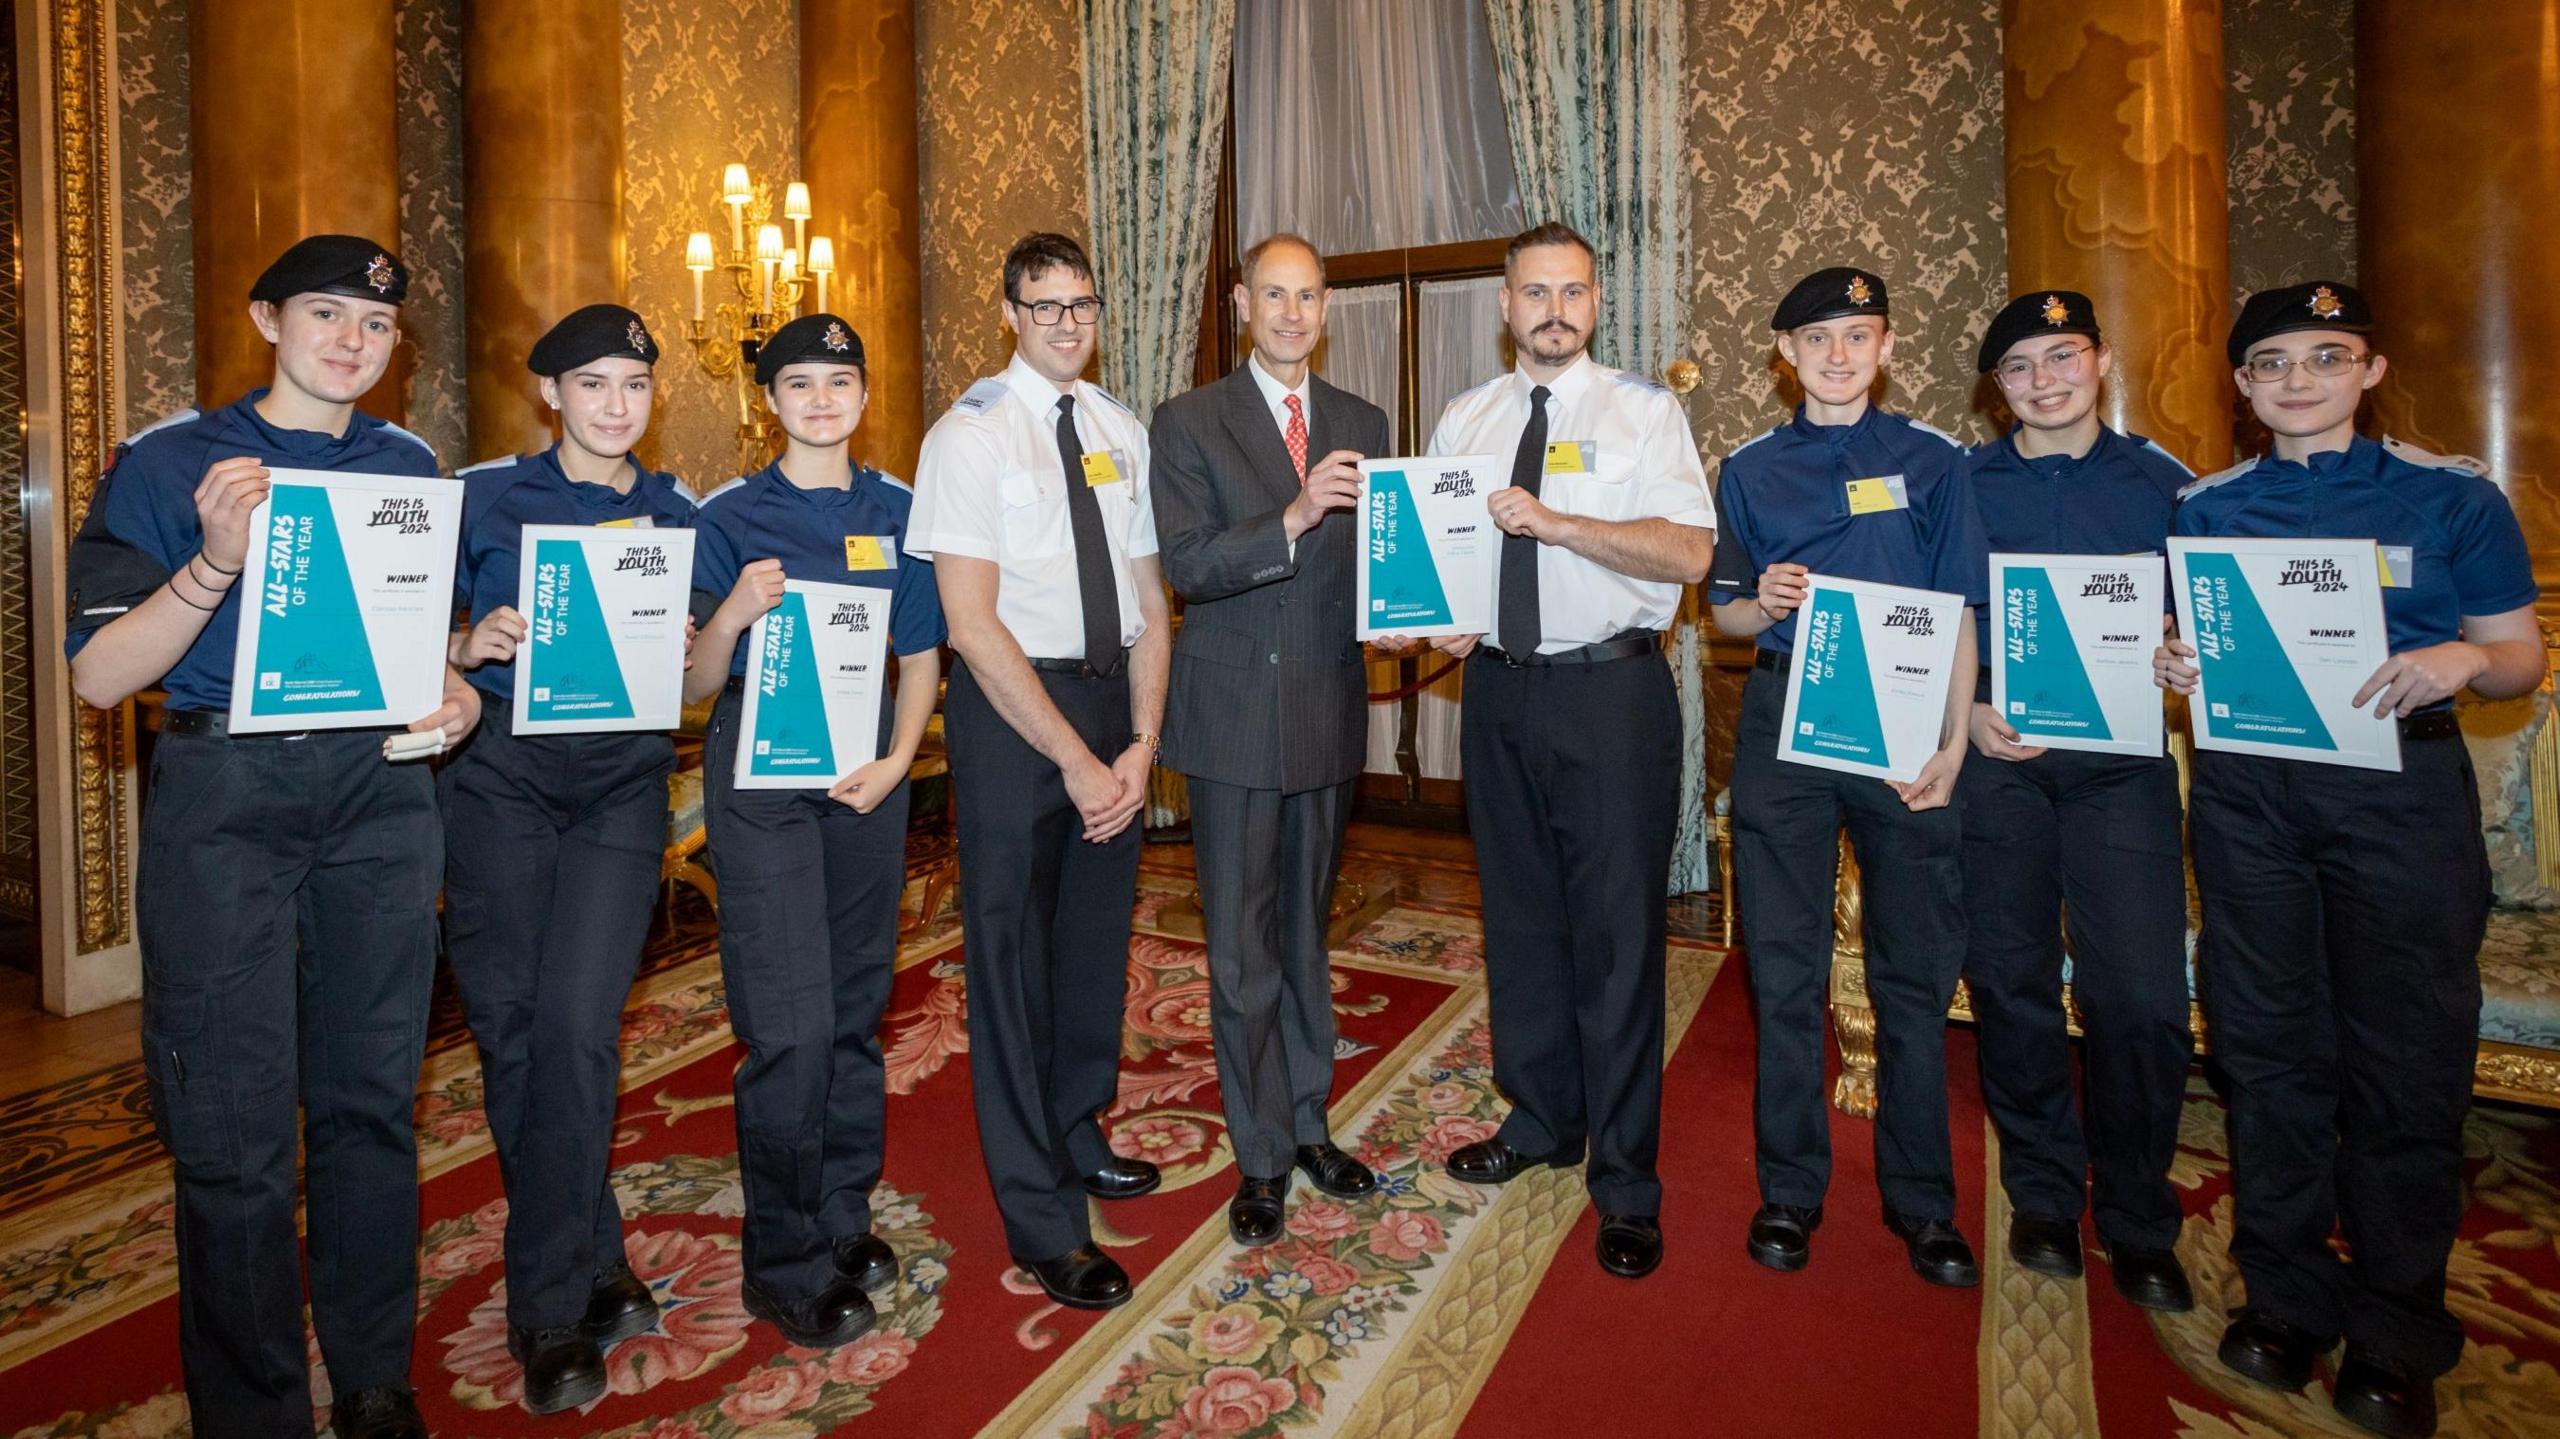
[1485,0,1715,894]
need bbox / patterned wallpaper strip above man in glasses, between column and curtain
[916,0,1085,422]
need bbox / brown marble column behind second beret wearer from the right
[2002,0,2222,471]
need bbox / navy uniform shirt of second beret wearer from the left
[453,446,694,699]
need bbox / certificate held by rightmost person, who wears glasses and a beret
[2168,538,2399,773]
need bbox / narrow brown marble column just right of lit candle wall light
[801,0,924,479]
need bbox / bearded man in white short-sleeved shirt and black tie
[1431,223,1715,1278]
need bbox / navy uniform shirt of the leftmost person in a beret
[61,389,440,709]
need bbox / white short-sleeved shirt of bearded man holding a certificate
[1431,356,1715,655]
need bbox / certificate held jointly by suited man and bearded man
[1359,456,1510,640]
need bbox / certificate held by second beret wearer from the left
[512,525,694,735]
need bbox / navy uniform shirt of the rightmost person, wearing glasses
[2176,435,2542,655]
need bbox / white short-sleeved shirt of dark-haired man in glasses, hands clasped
[906,353,1155,661]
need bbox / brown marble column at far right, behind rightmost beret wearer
[2355,0,2560,612]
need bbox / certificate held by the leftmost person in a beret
[230,469,463,735]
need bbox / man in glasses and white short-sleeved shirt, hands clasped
[906,233,1170,1308]
